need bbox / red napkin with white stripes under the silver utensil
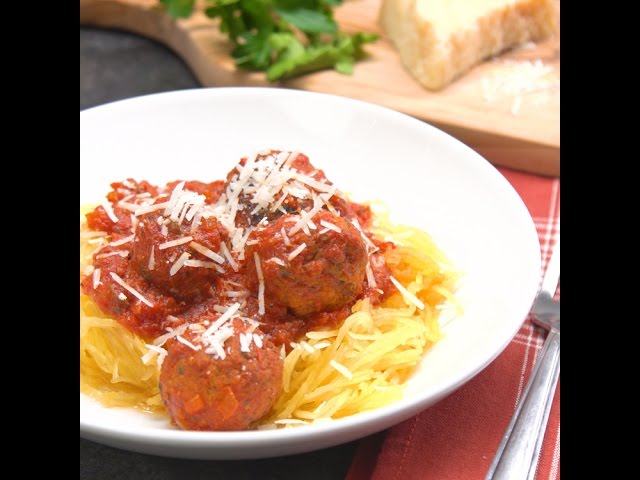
[347,168,560,480]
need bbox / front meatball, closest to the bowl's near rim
[160,318,283,431]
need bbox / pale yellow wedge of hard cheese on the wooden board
[380,0,559,90]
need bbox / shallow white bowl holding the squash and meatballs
[80,88,540,459]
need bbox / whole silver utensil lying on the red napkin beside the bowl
[485,235,560,480]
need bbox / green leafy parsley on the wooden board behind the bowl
[160,0,378,82]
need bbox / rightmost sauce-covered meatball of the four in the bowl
[247,210,367,317]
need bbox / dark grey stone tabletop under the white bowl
[80,28,364,480]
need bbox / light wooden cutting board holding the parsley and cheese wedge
[80,0,560,176]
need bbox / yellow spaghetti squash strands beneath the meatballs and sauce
[80,209,458,427]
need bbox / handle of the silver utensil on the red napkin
[485,329,560,480]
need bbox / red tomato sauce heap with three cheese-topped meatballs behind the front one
[81,150,395,348]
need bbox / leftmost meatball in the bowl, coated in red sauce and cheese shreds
[131,214,228,303]
